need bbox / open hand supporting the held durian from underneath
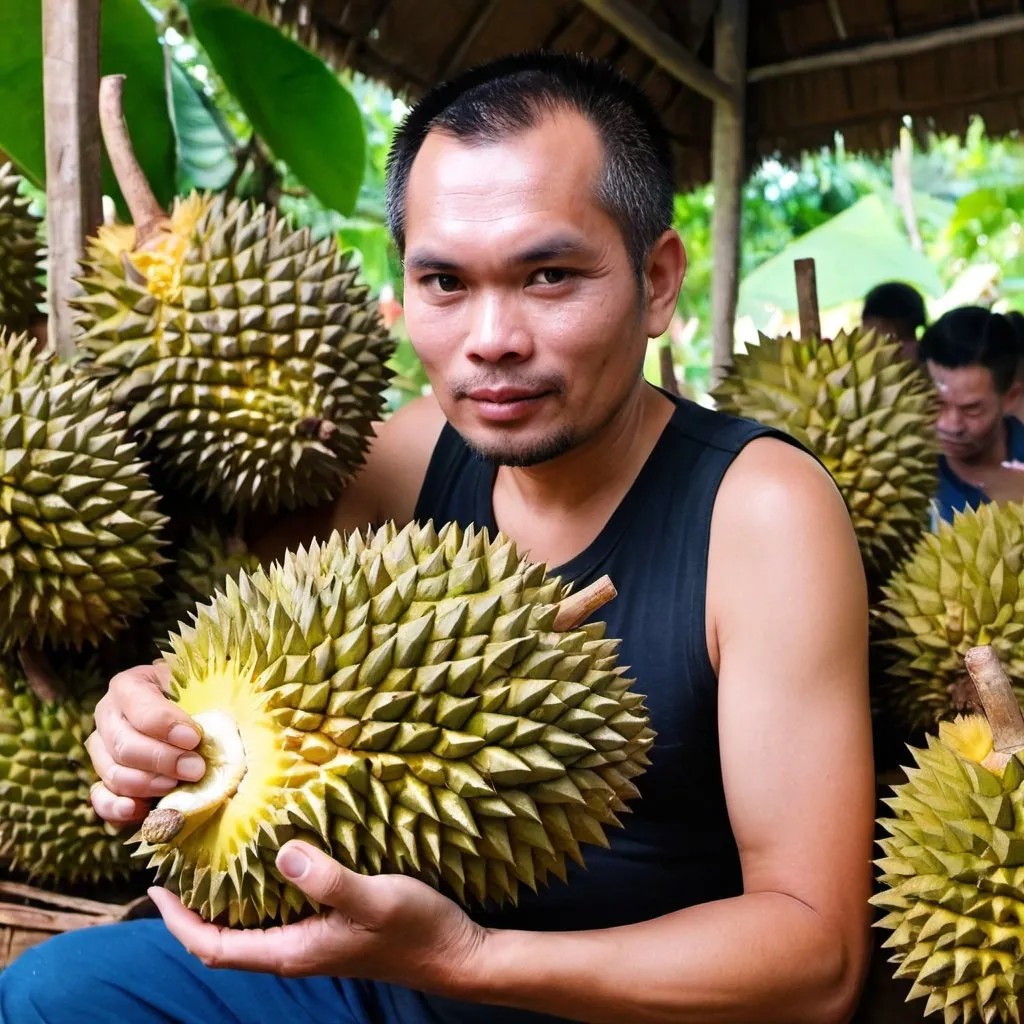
[150,841,486,994]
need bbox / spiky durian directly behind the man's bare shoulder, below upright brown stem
[712,331,938,581]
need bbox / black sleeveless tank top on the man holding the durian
[405,395,795,1024]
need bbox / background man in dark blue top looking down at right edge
[921,306,1024,521]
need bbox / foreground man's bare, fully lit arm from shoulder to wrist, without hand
[460,440,873,1024]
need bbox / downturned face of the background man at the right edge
[928,361,1019,462]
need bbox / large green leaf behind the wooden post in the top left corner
[0,0,175,209]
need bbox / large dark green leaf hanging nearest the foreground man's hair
[184,0,366,214]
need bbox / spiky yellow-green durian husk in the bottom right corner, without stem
[871,715,1024,1024]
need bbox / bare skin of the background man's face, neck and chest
[928,360,1024,501]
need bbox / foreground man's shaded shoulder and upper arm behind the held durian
[252,395,444,562]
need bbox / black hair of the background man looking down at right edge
[921,306,1024,394]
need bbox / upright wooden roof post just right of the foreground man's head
[711,0,750,387]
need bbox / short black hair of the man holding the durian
[386,52,675,278]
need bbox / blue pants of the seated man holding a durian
[0,919,442,1024]
